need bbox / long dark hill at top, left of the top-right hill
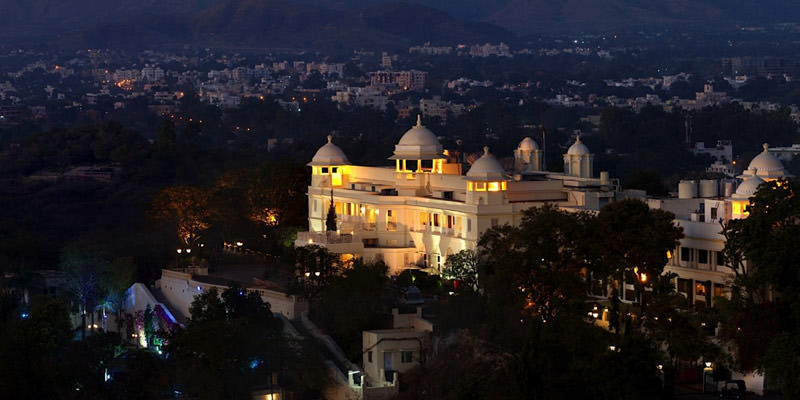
[51,0,516,50]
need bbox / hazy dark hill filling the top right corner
[484,0,800,34]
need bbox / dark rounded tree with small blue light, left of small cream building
[167,286,291,399]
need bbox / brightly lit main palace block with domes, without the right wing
[295,118,621,273]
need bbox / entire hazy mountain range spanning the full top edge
[6,0,800,49]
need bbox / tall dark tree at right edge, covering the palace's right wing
[723,179,800,398]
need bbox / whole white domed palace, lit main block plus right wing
[295,118,789,306]
